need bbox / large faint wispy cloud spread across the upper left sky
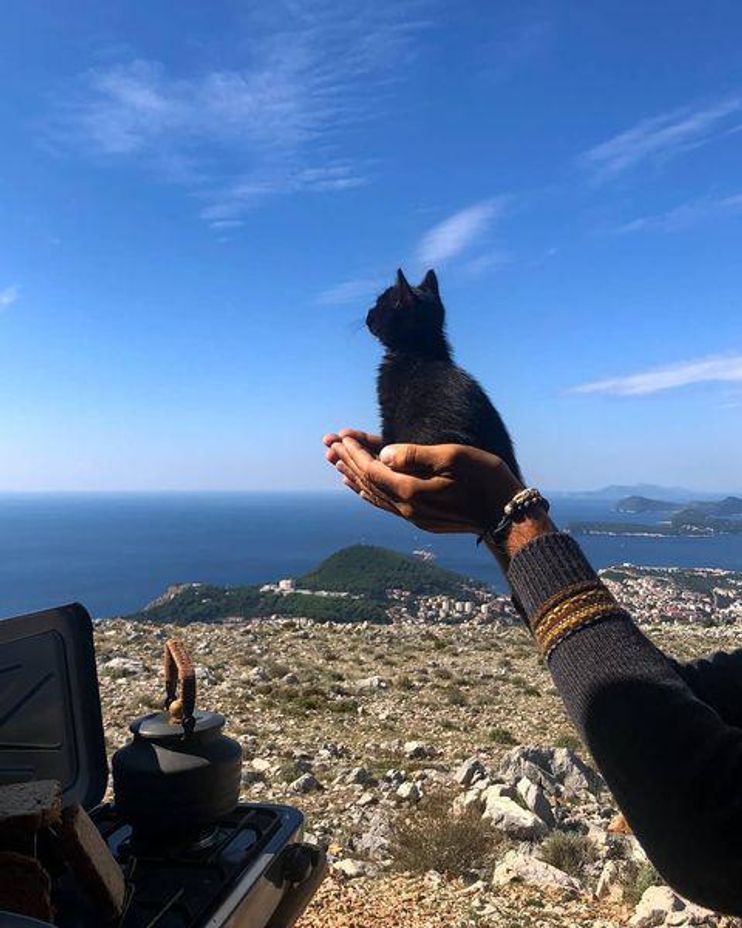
[48,0,427,222]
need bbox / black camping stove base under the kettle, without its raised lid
[49,803,324,928]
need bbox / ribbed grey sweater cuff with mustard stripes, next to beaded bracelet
[508,532,622,657]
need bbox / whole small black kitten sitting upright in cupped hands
[366,270,523,480]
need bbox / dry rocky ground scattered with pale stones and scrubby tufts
[96,620,742,928]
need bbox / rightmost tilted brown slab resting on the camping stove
[61,804,126,919]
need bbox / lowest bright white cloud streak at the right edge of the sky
[569,354,742,396]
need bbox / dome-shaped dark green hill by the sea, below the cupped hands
[296,545,486,599]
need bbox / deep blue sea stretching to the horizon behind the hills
[0,491,742,618]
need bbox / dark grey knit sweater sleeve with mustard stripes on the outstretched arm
[508,526,742,914]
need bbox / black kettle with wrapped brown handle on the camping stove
[112,639,242,838]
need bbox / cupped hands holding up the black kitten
[324,429,522,534]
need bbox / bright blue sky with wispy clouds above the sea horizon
[0,0,742,490]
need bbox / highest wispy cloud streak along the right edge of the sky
[580,97,742,176]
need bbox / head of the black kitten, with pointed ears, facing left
[366,270,446,351]
